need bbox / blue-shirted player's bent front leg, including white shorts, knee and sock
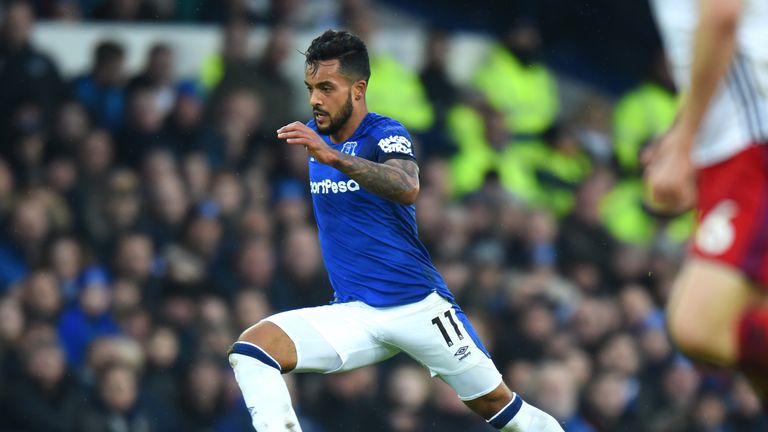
[229,304,397,432]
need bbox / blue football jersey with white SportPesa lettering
[307,113,453,307]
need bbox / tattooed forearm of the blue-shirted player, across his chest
[333,153,419,204]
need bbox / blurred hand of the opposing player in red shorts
[644,127,696,213]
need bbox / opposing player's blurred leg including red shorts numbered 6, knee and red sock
[667,145,768,397]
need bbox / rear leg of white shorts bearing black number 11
[386,294,502,401]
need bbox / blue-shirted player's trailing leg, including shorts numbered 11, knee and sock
[382,294,562,432]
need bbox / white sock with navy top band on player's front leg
[229,342,301,432]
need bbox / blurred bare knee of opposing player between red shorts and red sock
[667,257,763,366]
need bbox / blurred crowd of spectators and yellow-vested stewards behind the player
[0,0,768,432]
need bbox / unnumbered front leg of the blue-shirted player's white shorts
[266,304,397,373]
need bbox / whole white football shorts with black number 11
[266,293,501,401]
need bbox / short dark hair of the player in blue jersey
[304,30,371,82]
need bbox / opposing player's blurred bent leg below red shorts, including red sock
[667,257,768,397]
